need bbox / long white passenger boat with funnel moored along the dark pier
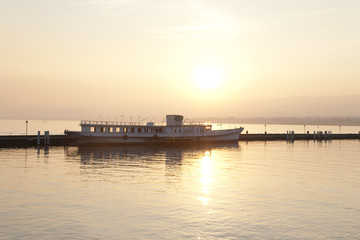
[67,115,244,145]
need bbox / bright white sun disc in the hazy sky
[194,66,224,90]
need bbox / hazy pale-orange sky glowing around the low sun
[0,0,360,119]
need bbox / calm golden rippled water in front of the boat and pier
[0,140,360,239]
